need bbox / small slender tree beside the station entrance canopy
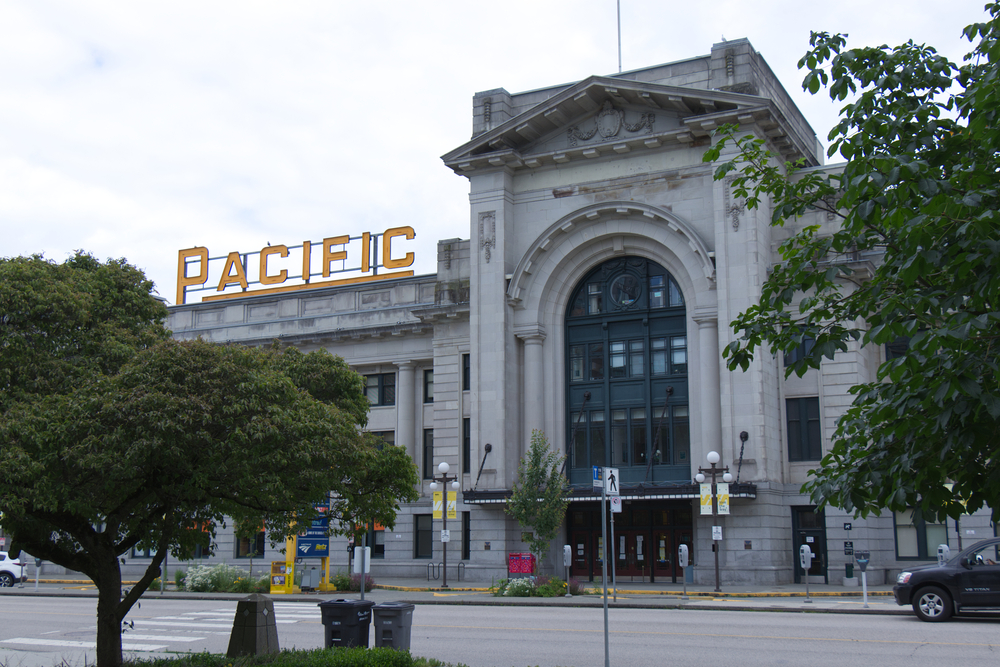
[505,430,569,576]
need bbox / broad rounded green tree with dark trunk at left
[0,254,416,667]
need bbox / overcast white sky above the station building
[0,0,986,302]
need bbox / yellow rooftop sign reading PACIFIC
[175,227,416,305]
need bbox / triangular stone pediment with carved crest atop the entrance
[442,76,808,173]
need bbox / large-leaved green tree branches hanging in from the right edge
[705,4,1000,520]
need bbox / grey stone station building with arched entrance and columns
[160,40,993,585]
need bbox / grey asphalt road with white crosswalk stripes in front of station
[0,597,1000,667]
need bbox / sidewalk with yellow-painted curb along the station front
[0,576,913,615]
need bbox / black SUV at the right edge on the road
[892,537,1000,621]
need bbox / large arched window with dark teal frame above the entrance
[566,257,691,484]
